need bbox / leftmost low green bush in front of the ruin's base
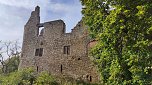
[0,69,34,85]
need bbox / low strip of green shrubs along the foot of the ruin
[0,68,97,85]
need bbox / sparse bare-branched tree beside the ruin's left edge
[0,41,21,73]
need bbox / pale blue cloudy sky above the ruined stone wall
[0,0,82,42]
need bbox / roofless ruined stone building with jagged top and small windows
[19,6,99,82]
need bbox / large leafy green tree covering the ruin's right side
[81,0,152,85]
